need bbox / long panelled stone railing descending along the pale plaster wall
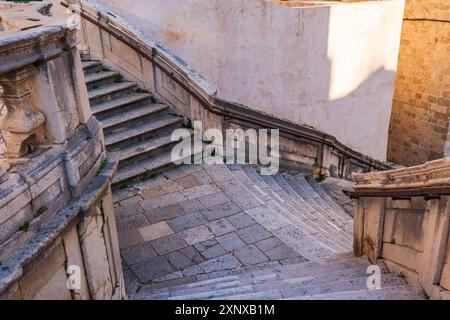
[61,0,392,178]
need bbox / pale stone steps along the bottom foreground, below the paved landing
[130,255,424,300]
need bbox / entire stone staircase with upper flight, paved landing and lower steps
[83,60,424,300]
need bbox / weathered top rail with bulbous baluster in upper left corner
[0,3,77,158]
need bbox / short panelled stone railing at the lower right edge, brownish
[346,158,450,299]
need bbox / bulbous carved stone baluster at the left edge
[0,66,45,158]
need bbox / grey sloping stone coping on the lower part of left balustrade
[0,152,118,293]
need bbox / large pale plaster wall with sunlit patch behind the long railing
[87,0,403,160]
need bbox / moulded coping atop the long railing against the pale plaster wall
[65,0,393,178]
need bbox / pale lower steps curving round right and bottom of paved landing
[123,165,425,300]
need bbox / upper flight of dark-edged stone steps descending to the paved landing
[82,60,192,188]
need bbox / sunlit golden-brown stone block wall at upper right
[388,0,450,166]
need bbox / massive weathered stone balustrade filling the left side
[0,1,124,300]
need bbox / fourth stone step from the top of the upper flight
[91,93,152,120]
